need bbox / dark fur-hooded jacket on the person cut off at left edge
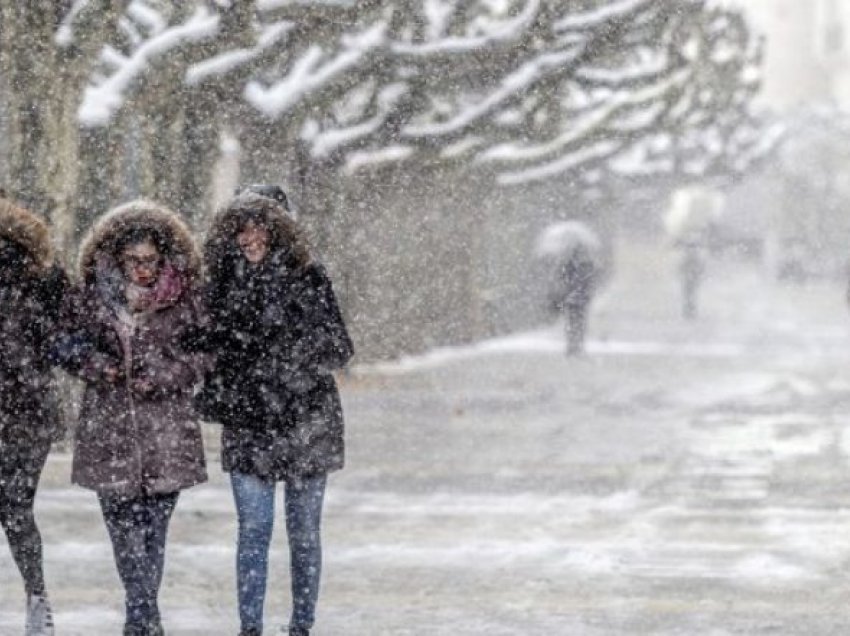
[0,198,68,456]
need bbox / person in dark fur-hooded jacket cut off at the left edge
[0,198,67,636]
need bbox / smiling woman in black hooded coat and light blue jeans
[198,193,353,636]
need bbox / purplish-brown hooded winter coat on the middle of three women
[64,201,207,496]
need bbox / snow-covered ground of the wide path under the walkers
[0,241,850,636]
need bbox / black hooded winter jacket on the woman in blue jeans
[202,196,353,480]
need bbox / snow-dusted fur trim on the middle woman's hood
[78,199,201,281]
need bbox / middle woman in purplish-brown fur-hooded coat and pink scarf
[59,201,206,636]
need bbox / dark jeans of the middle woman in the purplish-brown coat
[98,492,178,631]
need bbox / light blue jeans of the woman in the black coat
[230,472,327,631]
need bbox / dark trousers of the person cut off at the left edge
[0,439,50,594]
